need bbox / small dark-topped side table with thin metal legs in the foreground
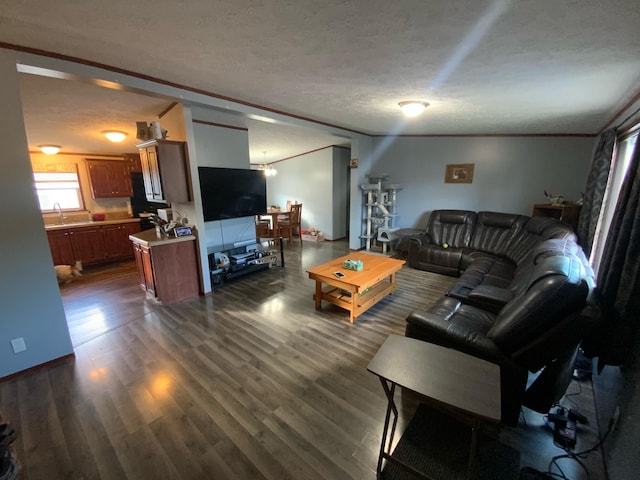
[367,335,501,479]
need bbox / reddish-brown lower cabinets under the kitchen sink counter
[47,222,140,266]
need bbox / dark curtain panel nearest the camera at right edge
[585,144,640,368]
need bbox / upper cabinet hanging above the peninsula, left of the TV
[138,140,191,203]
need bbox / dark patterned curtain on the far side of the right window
[577,128,616,257]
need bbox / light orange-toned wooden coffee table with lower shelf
[307,252,405,323]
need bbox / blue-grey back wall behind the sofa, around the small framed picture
[368,137,594,231]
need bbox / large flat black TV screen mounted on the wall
[198,167,267,222]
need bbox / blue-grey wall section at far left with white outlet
[0,51,73,377]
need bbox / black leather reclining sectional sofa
[405,210,596,425]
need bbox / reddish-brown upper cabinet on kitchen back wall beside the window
[87,159,133,198]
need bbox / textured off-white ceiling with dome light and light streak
[0,0,640,161]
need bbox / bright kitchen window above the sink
[33,170,84,213]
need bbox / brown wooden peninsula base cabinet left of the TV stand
[129,229,200,304]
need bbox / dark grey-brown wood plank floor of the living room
[0,241,606,480]
